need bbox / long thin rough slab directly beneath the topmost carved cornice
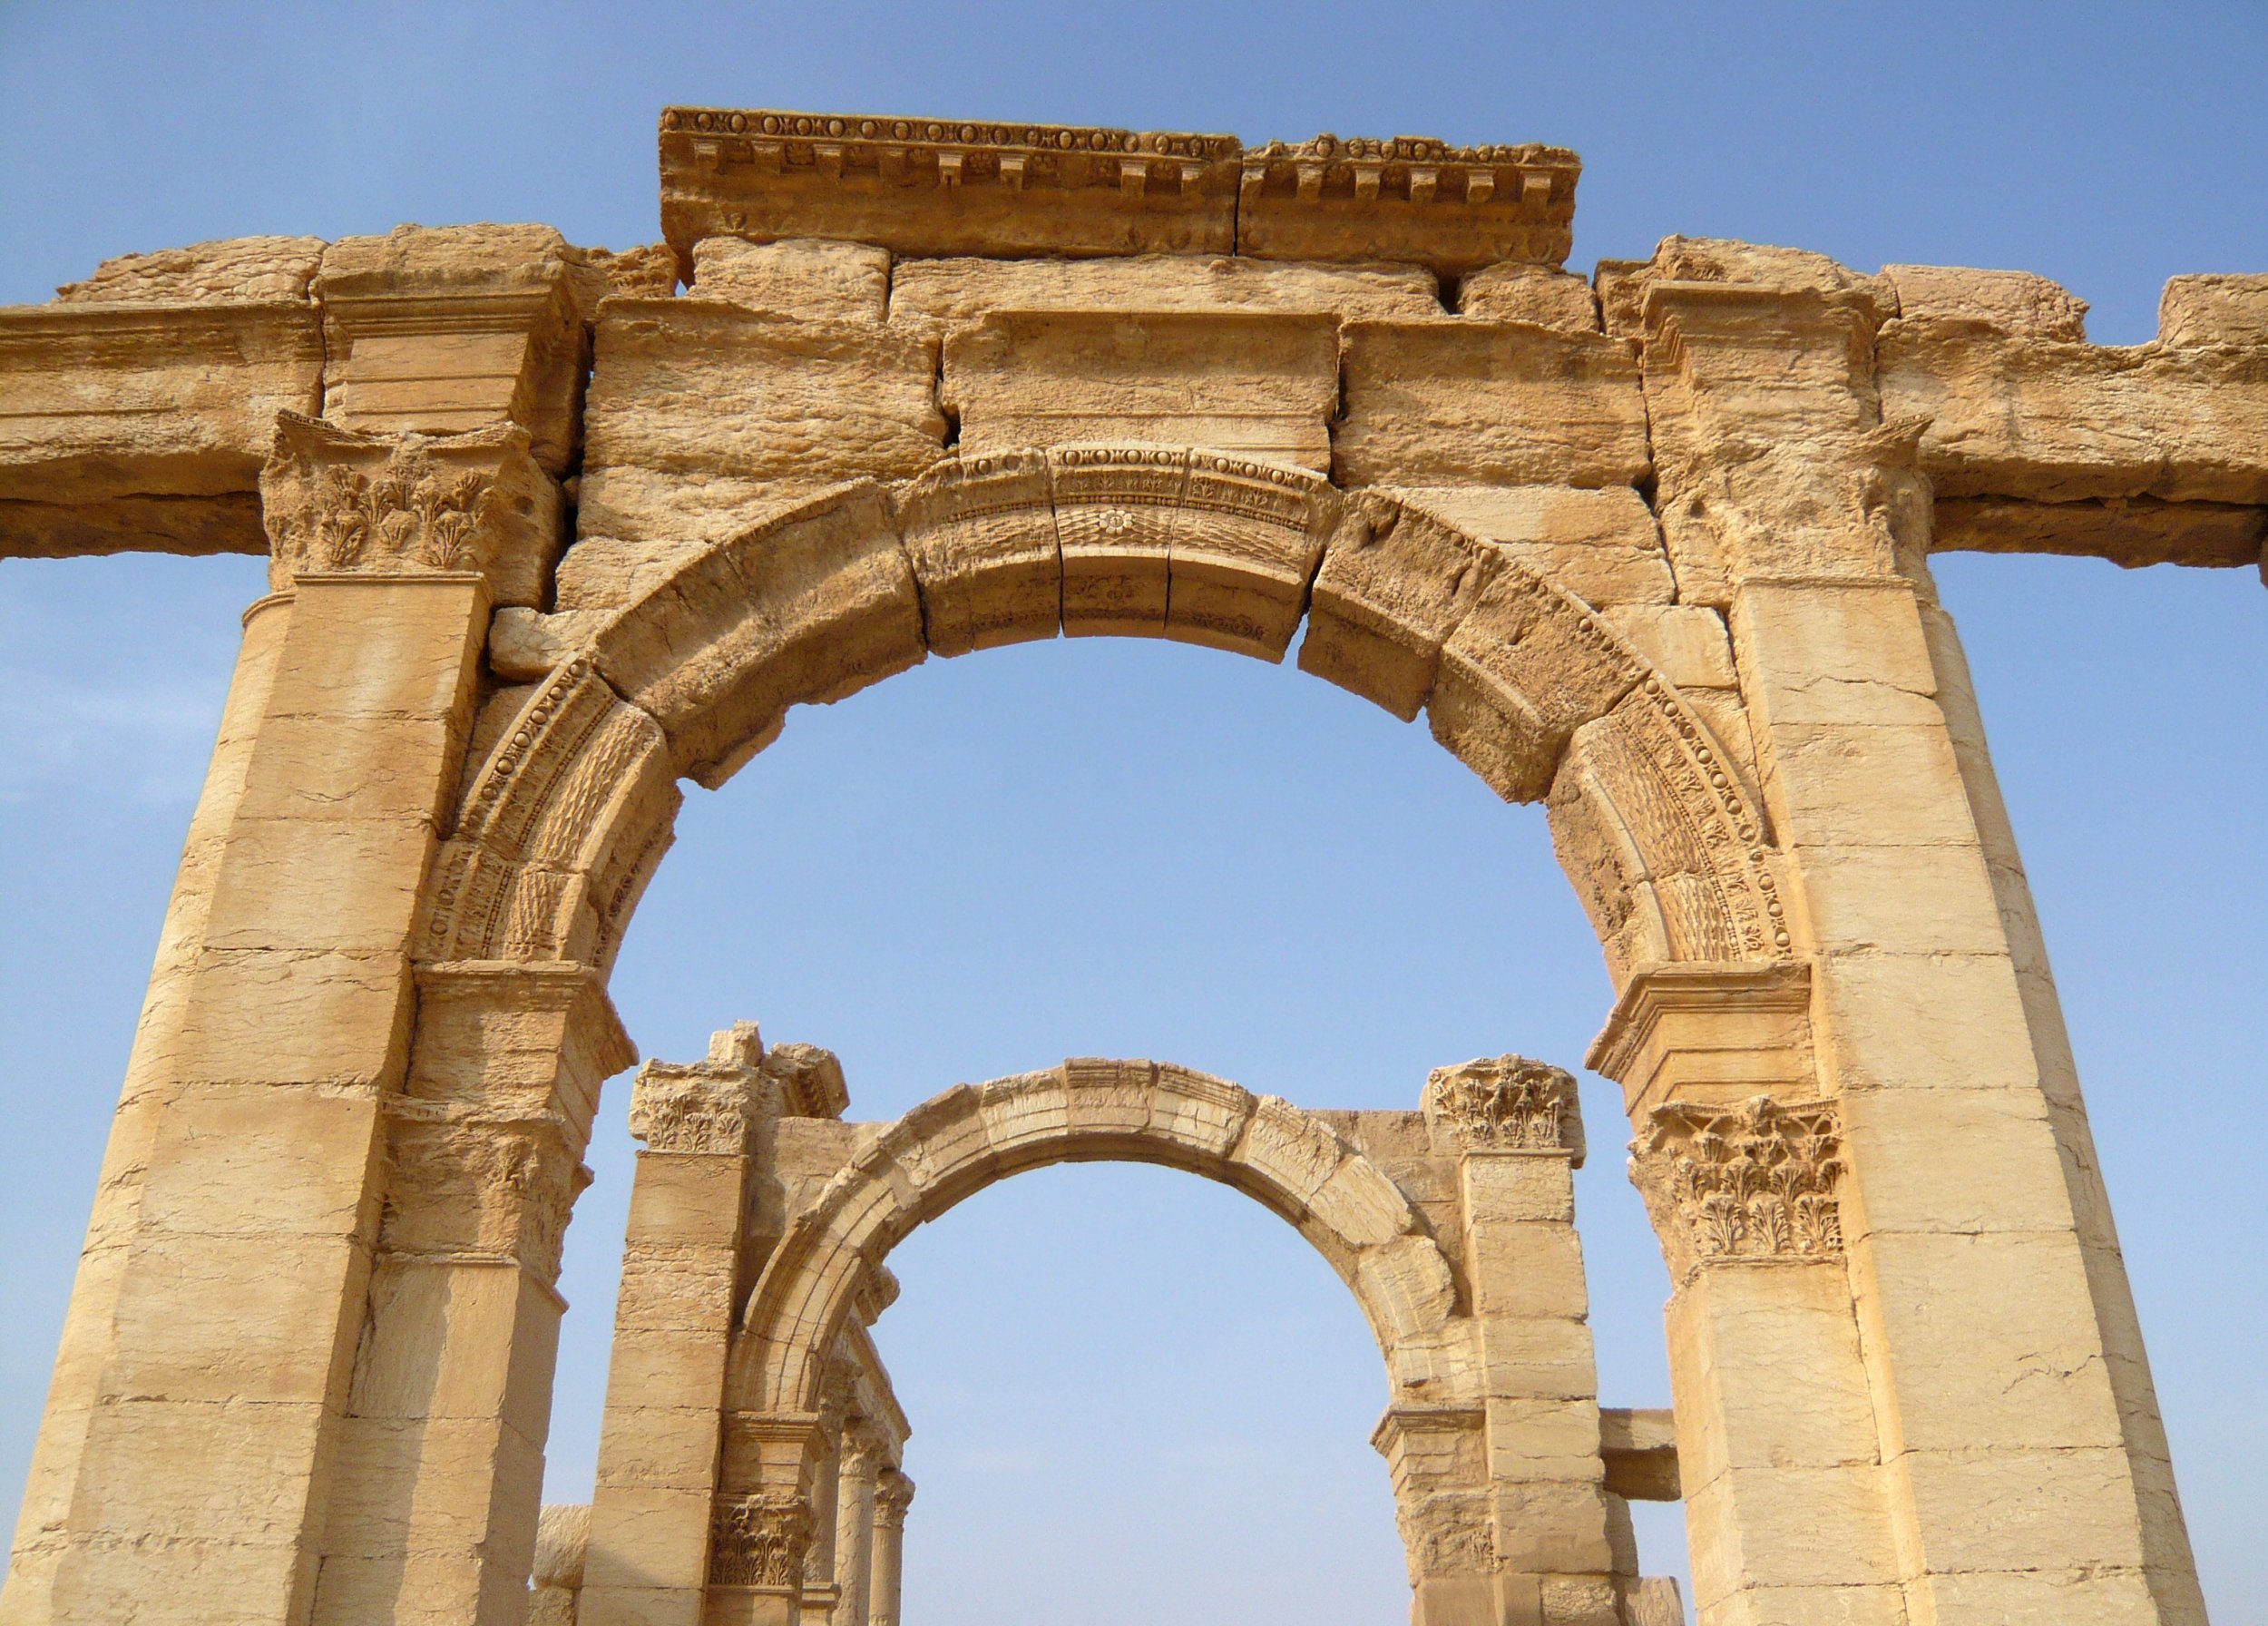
[889,254,1441,336]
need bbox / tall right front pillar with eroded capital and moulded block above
[1642,238,2203,1626]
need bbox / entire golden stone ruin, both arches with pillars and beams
[0,109,2268,1626]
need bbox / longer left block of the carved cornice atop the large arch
[660,106,1243,269]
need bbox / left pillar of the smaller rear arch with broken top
[581,1023,778,1626]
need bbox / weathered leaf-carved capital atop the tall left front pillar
[261,413,562,603]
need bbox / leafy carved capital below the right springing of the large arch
[1631,1095,1844,1281]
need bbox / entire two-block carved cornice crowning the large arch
[660,106,1583,281]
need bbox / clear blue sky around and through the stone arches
[0,0,2268,1626]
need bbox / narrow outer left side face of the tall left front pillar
[0,592,293,1621]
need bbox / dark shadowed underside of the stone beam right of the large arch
[1932,496,2268,567]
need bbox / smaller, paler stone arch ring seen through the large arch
[726,1059,1479,1415]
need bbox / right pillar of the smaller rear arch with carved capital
[1418,1057,1637,1626]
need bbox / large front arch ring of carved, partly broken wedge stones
[420,446,1796,986]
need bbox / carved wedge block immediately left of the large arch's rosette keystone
[898,451,1064,655]
